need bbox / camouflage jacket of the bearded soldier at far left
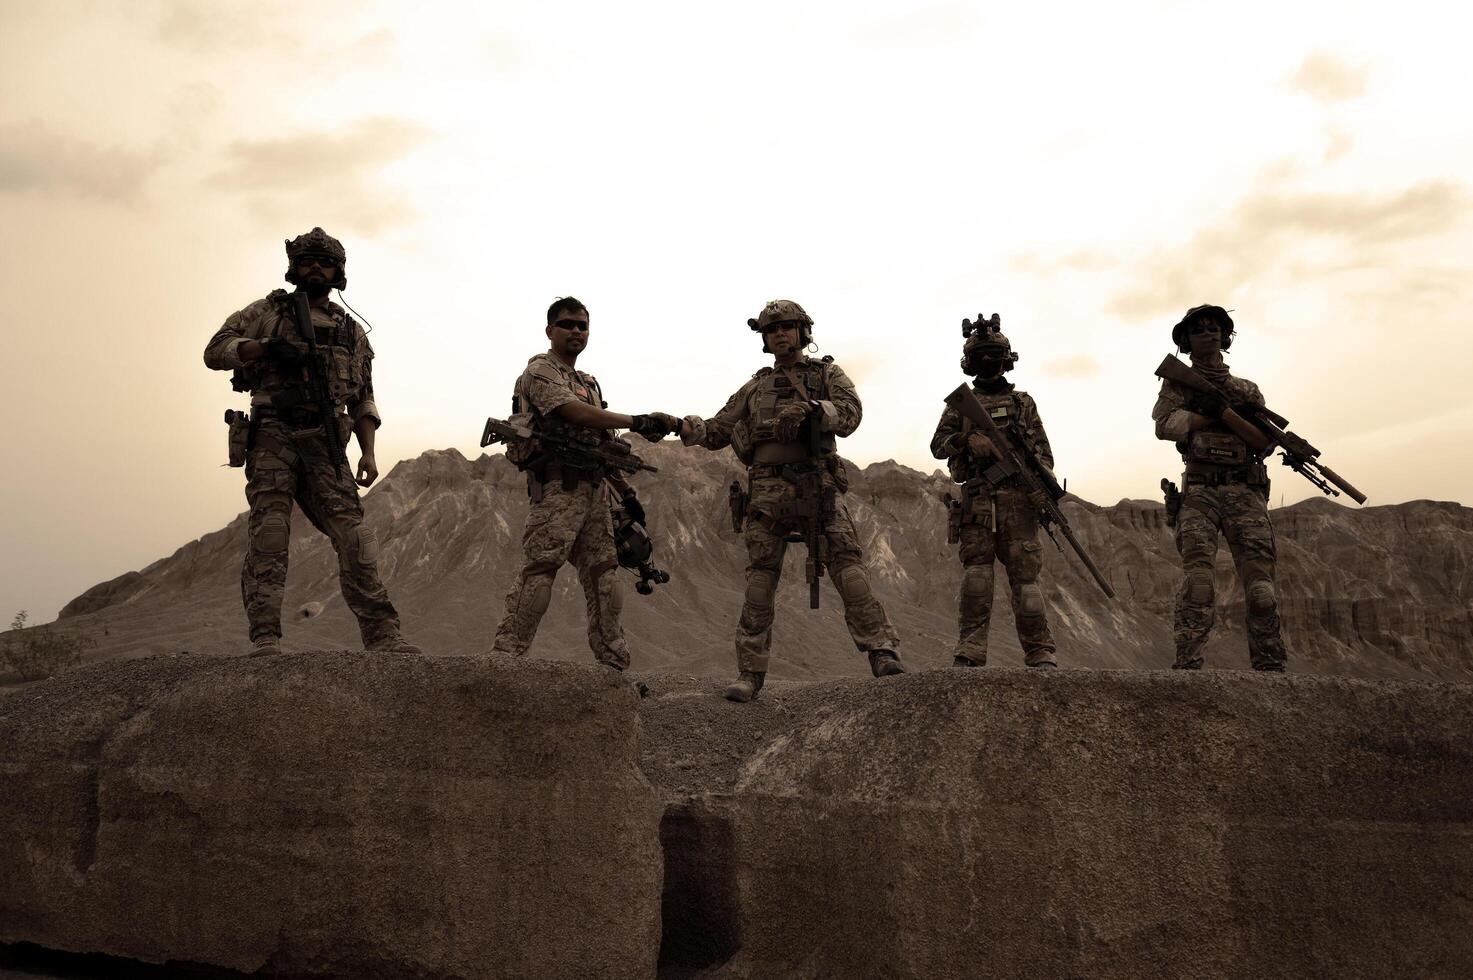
[205,289,383,424]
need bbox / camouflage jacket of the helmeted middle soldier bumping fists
[683,357,865,464]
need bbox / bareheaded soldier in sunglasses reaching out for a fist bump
[492,296,679,671]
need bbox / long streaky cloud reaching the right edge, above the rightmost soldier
[1109,181,1467,320]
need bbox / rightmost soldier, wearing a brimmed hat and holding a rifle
[1150,307,1286,671]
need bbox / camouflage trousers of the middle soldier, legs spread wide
[737,475,900,673]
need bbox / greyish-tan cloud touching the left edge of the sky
[0,121,161,203]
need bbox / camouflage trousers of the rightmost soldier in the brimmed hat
[1173,483,1286,669]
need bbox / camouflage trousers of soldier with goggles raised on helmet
[953,488,1056,666]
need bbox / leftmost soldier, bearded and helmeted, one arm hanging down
[205,228,420,654]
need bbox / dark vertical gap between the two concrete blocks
[658,802,741,980]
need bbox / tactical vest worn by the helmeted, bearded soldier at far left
[230,289,368,408]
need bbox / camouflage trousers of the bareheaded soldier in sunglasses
[492,480,629,671]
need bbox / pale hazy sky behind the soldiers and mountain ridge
[0,0,1473,620]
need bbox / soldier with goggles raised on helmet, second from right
[931,314,1058,669]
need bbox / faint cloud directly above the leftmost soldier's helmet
[209,116,429,234]
